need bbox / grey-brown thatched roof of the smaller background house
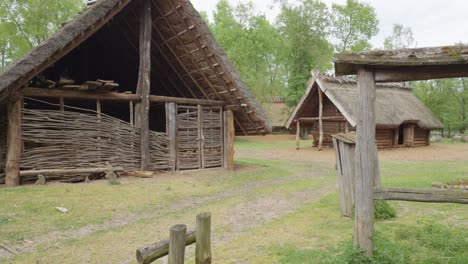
[286,75,443,129]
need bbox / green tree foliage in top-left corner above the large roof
[0,0,85,67]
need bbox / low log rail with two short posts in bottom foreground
[136,213,212,264]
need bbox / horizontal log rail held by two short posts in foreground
[136,231,196,264]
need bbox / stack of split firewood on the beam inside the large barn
[31,77,119,92]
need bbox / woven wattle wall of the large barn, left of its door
[17,109,171,171]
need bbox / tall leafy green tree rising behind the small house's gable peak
[277,0,333,106]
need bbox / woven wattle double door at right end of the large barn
[176,105,224,170]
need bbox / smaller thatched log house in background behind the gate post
[286,74,443,148]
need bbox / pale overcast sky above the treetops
[192,0,468,48]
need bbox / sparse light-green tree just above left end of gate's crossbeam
[332,0,379,52]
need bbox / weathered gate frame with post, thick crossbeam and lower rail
[333,46,468,256]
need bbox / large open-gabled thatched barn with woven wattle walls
[0,0,271,186]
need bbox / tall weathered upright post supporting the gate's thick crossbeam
[354,68,377,256]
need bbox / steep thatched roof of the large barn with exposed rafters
[0,0,271,134]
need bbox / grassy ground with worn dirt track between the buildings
[0,137,468,263]
